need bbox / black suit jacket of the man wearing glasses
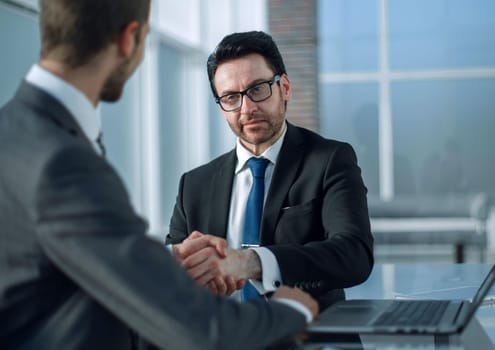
[167,123,373,308]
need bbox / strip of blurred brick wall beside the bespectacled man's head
[268,0,319,131]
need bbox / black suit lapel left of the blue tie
[208,149,236,238]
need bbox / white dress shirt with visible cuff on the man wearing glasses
[227,124,287,294]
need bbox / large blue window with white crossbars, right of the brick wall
[318,0,495,199]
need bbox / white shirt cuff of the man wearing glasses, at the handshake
[249,247,282,294]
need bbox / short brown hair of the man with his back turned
[40,0,150,68]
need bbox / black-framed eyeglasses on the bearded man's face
[215,74,280,112]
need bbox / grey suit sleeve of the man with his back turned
[33,147,305,349]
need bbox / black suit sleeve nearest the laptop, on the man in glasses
[268,143,373,296]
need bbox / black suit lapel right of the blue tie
[260,123,304,245]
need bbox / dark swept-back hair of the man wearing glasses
[206,31,287,97]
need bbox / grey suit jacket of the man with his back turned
[0,82,305,350]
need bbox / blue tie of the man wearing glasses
[242,157,270,301]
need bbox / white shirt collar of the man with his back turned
[26,64,101,143]
